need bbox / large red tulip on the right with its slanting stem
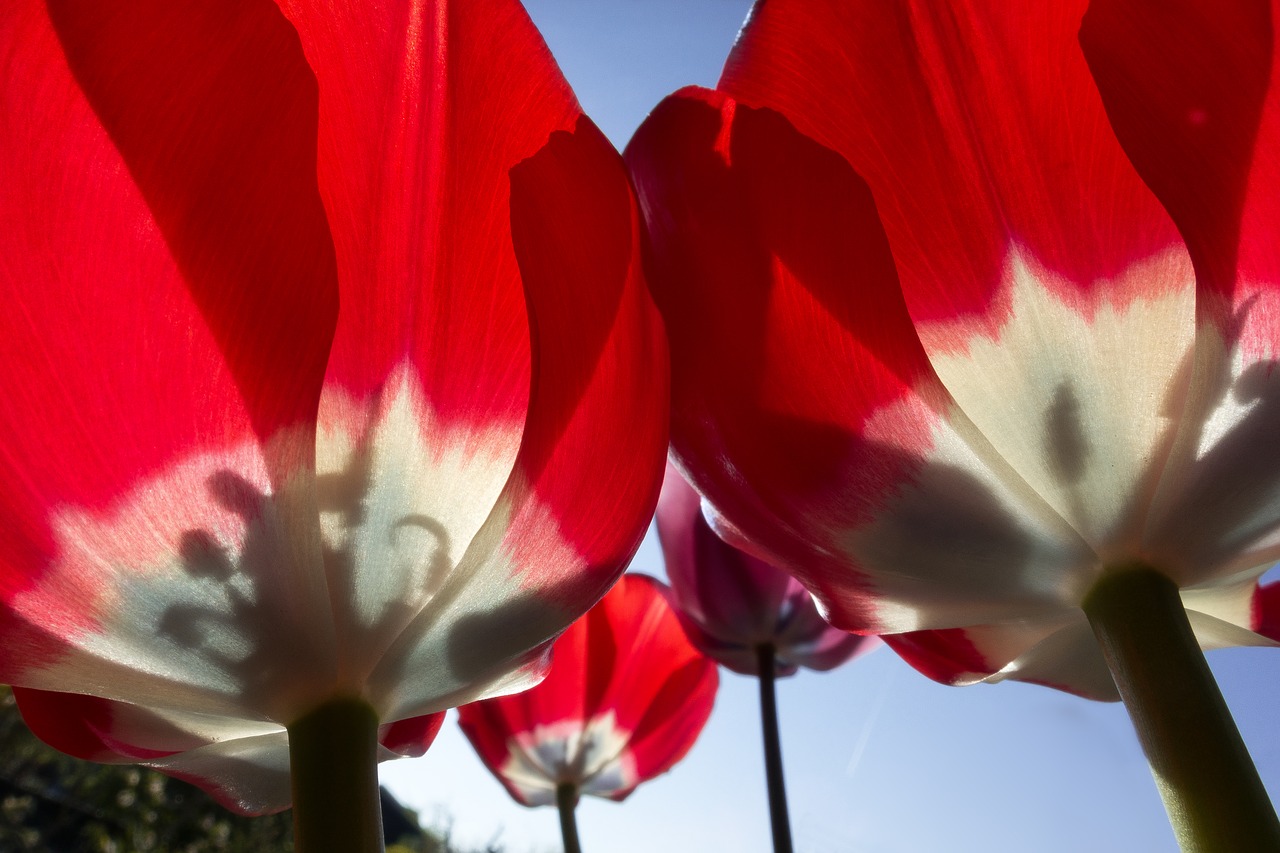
[626,0,1280,849]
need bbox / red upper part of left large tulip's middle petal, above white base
[280,0,581,432]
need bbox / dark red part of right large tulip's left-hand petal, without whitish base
[626,90,946,628]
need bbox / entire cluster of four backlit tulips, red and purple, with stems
[0,0,1280,853]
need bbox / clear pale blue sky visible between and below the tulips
[381,0,1280,853]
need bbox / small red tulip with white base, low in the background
[458,574,718,852]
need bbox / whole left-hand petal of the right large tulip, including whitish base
[626,91,1092,631]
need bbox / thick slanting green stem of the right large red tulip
[1084,565,1280,853]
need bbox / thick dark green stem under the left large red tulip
[288,698,383,853]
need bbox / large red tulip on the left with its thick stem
[0,0,667,849]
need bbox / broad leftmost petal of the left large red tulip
[0,0,337,707]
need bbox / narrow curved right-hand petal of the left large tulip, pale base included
[358,119,667,715]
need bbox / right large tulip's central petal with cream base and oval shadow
[722,0,1194,571]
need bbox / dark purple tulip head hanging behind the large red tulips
[657,465,878,676]
